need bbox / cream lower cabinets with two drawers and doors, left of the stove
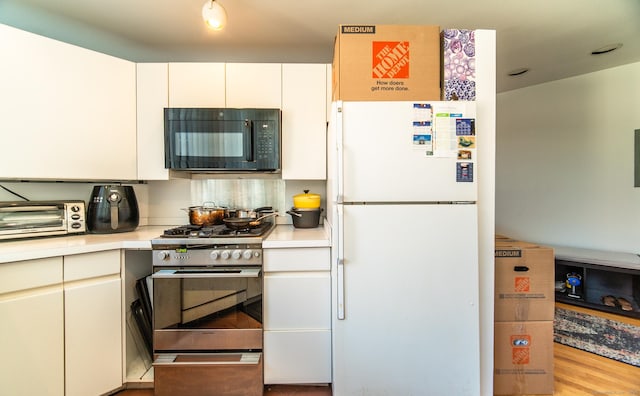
[0,249,122,396]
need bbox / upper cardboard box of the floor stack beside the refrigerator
[494,241,555,322]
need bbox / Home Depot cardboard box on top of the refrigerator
[332,25,440,101]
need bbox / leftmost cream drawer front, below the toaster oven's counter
[0,257,62,294]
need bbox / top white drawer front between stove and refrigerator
[263,247,331,272]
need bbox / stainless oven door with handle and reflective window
[152,266,262,352]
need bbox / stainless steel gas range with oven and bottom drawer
[151,222,275,396]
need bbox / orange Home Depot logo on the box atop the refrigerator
[372,41,409,78]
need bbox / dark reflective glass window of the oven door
[153,268,262,330]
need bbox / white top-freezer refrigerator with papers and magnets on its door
[327,101,482,396]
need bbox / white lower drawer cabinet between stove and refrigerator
[263,248,331,384]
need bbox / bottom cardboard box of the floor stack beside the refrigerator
[493,320,554,395]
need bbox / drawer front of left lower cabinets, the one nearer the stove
[64,250,120,282]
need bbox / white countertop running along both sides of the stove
[0,224,331,263]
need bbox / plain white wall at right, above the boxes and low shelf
[496,63,640,253]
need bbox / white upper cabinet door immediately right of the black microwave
[282,64,327,180]
